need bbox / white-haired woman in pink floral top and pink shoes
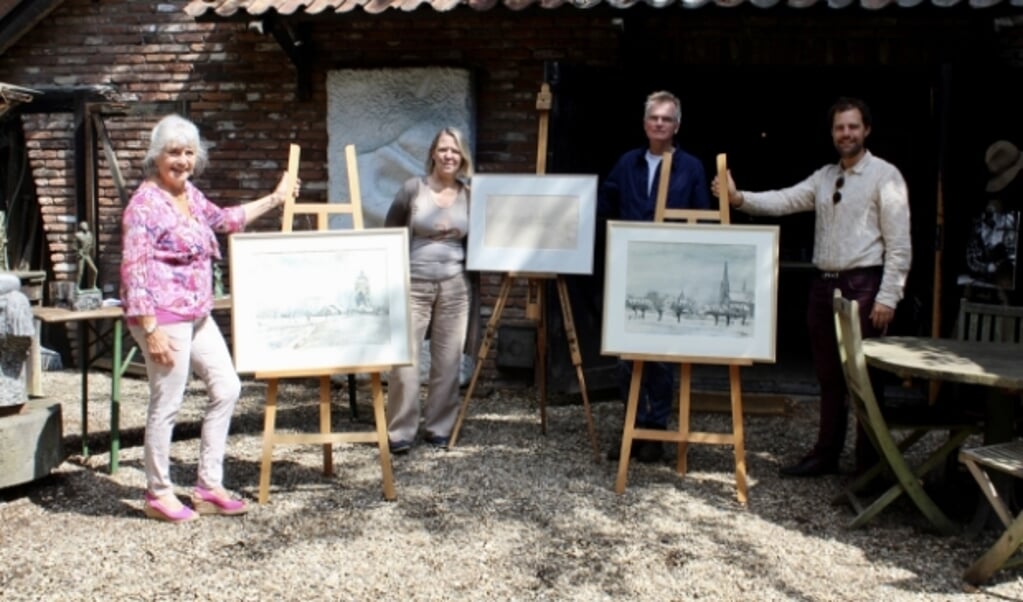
[121,115,296,522]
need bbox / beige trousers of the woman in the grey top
[387,273,469,442]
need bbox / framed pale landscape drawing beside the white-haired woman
[229,228,412,375]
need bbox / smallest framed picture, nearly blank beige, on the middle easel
[465,174,597,274]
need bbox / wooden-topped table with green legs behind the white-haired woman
[32,307,135,474]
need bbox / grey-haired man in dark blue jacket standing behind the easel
[597,91,711,463]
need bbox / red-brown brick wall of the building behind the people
[0,0,1023,374]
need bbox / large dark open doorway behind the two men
[547,65,939,391]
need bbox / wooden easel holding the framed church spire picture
[615,153,753,504]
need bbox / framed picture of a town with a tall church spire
[601,221,779,363]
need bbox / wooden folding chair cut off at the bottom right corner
[959,440,1023,586]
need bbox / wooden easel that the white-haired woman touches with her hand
[256,144,395,504]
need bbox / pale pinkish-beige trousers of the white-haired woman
[129,317,241,496]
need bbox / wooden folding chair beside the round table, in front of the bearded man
[834,292,977,533]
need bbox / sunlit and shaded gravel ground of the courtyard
[0,372,1023,600]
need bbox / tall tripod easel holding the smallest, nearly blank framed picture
[449,84,601,460]
